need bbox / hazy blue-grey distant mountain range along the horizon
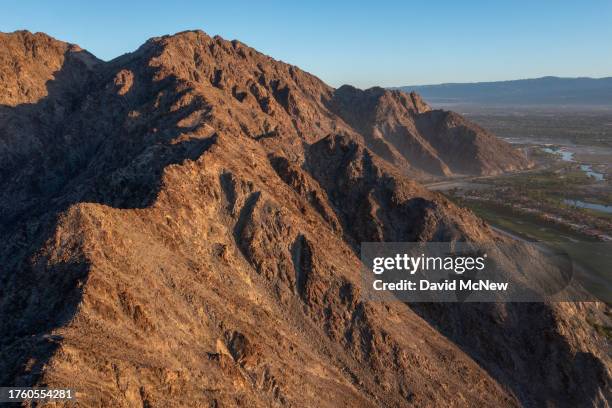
[396,76,612,107]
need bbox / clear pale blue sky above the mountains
[0,0,612,88]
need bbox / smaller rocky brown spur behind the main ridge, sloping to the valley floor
[330,85,529,176]
